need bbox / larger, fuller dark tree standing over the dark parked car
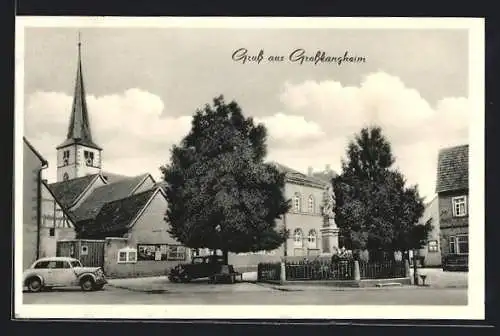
[161,96,290,262]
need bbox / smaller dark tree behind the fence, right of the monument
[333,127,431,260]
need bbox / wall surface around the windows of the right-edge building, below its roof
[439,190,469,256]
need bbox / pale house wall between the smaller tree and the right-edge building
[419,196,441,266]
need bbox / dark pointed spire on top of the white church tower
[58,33,102,150]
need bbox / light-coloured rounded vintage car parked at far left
[23,257,107,292]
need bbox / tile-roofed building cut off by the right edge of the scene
[436,145,469,267]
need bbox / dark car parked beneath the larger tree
[168,256,224,282]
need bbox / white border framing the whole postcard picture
[14,17,485,320]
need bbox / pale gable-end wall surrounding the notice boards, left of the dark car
[105,192,190,277]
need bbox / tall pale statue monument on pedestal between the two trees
[321,183,339,254]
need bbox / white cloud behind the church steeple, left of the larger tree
[24,89,191,180]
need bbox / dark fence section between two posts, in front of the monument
[285,260,354,281]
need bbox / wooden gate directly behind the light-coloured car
[56,239,106,267]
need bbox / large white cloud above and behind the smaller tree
[270,72,471,201]
